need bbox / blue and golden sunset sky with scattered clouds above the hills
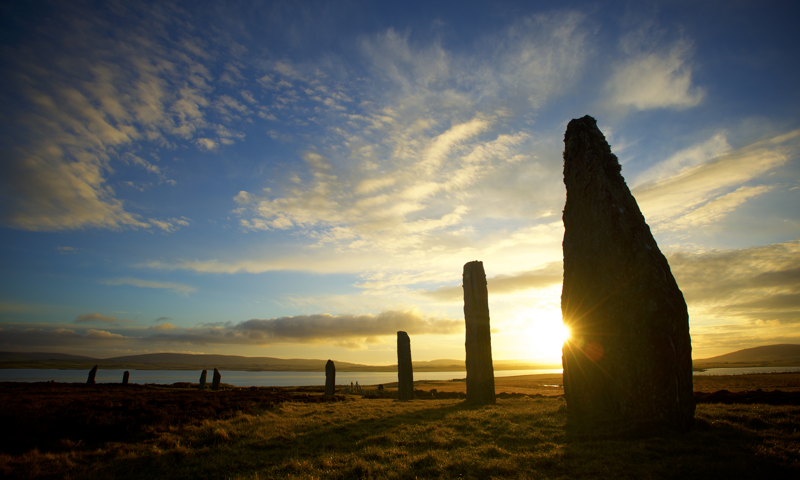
[0,0,800,365]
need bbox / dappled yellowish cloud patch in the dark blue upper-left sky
[0,4,242,231]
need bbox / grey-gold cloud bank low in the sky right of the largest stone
[668,240,800,324]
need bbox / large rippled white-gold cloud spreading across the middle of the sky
[234,12,588,246]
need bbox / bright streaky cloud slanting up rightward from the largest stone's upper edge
[633,129,800,232]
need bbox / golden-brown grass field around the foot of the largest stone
[0,374,800,479]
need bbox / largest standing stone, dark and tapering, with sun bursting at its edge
[561,116,695,429]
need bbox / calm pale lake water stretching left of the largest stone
[0,368,561,387]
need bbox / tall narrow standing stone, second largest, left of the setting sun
[463,260,496,405]
